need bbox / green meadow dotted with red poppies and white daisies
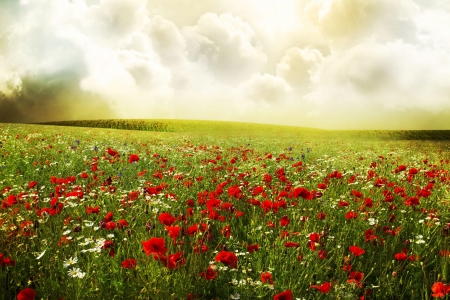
[0,120,450,299]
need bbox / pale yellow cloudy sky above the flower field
[0,0,450,130]
